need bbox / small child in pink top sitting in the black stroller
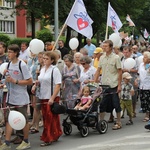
[74,86,92,110]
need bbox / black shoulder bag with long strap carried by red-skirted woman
[51,68,66,114]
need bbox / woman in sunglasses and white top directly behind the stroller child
[79,56,96,89]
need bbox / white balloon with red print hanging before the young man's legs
[8,110,26,130]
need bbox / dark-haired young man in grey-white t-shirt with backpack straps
[0,44,33,150]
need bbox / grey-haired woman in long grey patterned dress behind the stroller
[62,54,80,108]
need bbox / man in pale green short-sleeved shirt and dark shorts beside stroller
[95,40,122,130]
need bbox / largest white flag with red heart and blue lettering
[65,0,93,39]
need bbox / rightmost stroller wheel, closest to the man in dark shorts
[96,120,108,134]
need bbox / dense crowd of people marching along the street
[0,39,150,150]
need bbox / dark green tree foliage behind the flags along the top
[11,0,150,41]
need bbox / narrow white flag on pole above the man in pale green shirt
[107,3,122,33]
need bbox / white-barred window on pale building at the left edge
[0,20,15,33]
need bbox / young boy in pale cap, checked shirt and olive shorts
[121,72,134,125]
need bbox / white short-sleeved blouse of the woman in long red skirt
[38,65,62,99]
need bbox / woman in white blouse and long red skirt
[32,51,62,146]
